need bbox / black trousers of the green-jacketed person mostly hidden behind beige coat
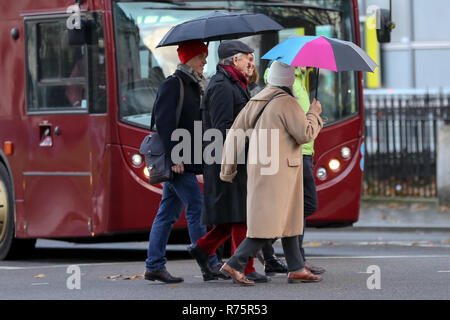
[262,155,318,261]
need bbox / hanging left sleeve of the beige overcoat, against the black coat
[220,108,248,182]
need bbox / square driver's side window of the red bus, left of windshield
[25,14,106,113]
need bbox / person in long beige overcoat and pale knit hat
[220,61,323,285]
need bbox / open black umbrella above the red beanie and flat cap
[157,11,283,48]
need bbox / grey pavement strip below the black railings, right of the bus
[353,198,450,232]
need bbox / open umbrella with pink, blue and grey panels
[261,36,377,98]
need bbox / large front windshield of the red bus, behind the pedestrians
[114,0,359,129]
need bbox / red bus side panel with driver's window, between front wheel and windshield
[19,12,107,237]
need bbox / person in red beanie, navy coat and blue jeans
[145,41,220,283]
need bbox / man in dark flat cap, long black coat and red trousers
[188,40,269,282]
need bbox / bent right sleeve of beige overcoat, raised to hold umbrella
[280,97,323,144]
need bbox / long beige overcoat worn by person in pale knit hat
[220,86,323,239]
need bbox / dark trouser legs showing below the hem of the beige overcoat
[227,236,305,272]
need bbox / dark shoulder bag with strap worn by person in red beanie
[139,76,184,184]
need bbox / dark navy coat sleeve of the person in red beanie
[154,77,180,165]
